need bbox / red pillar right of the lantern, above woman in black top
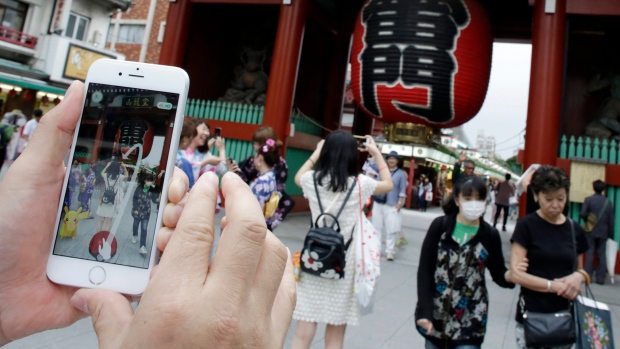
[520,0,566,215]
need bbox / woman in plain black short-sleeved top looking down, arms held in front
[510,166,588,349]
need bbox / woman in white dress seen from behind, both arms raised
[292,131,392,349]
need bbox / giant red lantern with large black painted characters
[351,0,493,127]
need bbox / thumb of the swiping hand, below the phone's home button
[71,289,133,348]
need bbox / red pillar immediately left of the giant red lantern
[263,0,308,148]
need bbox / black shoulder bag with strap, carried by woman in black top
[519,219,577,348]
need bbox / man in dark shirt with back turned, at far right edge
[579,180,614,285]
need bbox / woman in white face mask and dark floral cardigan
[415,177,527,349]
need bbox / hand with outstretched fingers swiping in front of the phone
[73,172,295,348]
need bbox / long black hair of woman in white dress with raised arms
[314,130,359,192]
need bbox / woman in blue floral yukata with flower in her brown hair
[236,126,295,230]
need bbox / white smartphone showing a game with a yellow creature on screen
[47,59,189,295]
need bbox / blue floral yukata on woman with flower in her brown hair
[237,155,295,229]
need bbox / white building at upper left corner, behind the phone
[0,0,130,116]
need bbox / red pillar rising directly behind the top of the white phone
[159,0,192,67]
